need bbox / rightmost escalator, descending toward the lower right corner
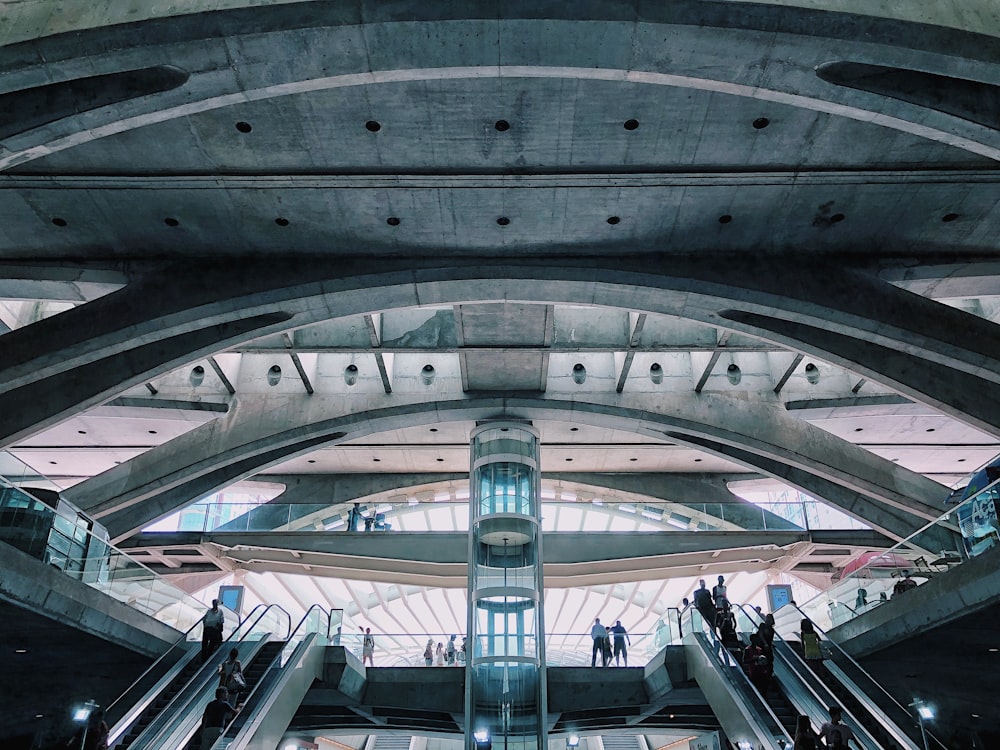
[734,606,922,750]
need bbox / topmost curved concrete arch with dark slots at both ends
[0,0,1000,169]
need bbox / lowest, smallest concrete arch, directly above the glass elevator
[64,394,944,540]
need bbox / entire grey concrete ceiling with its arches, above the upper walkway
[0,0,1000,746]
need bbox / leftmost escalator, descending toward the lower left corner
[109,606,290,750]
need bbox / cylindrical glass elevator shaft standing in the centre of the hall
[465,422,547,750]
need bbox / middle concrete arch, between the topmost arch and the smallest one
[0,257,1000,445]
